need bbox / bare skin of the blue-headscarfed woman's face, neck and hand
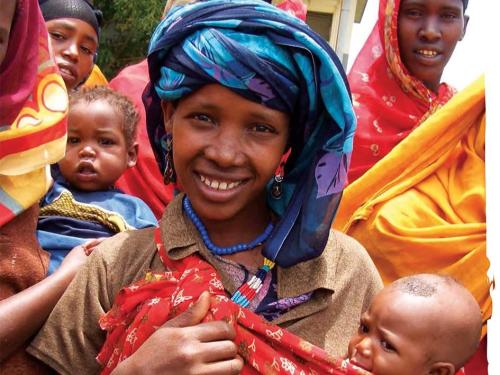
[113,84,289,375]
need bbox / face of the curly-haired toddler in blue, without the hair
[59,100,137,191]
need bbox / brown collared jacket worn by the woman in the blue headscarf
[28,197,382,374]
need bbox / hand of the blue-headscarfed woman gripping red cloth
[112,292,243,375]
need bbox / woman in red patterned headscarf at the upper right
[348,0,468,182]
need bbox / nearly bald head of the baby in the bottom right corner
[348,274,482,375]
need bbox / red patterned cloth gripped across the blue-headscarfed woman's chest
[97,230,370,375]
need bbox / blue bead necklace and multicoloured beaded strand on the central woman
[182,195,274,307]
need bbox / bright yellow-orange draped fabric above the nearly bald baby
[334,77,491,335]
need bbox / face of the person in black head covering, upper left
[46,18,98,91]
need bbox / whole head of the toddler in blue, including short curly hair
[59,86,139,191]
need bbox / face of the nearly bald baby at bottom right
[348,289,433,375]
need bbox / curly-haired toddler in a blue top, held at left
[37,86,156,274]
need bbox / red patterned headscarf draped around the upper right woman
[348,0,454,182]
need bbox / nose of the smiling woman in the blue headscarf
[205,131,245,168]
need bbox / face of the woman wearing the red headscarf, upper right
[398,0,467,92]
